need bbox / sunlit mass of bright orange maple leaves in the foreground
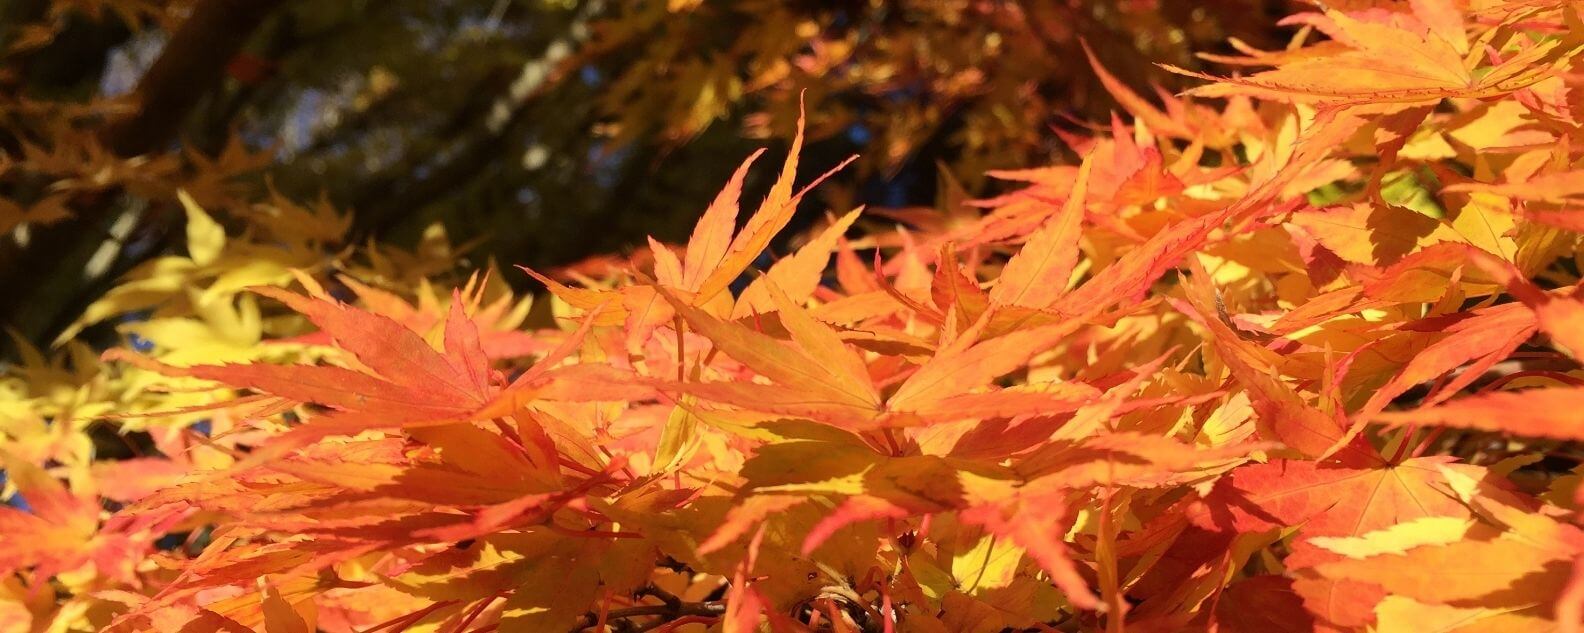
[0,0,1584,633]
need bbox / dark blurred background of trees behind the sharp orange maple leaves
[0,0,1289,356]
